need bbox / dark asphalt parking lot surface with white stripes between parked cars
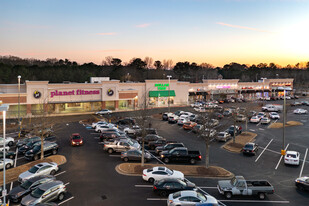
[2,99,309,206]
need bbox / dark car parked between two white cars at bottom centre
[153,178,196,196]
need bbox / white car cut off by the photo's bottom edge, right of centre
[167,190,218,206]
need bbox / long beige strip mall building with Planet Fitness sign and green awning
[0,77,293,117]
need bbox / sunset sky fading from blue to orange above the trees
[0,0,309,66]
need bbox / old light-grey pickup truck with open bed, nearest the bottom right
[217,176,275,200]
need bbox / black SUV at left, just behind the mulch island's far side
[25,142,59,161]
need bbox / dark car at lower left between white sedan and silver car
[8,175,56,202]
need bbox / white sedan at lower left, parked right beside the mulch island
[18,162,59,183]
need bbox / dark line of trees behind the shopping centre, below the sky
[0,56,309,87]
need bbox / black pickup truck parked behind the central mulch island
[160,147,202,164]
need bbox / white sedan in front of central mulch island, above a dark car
[143,167,184,183]
